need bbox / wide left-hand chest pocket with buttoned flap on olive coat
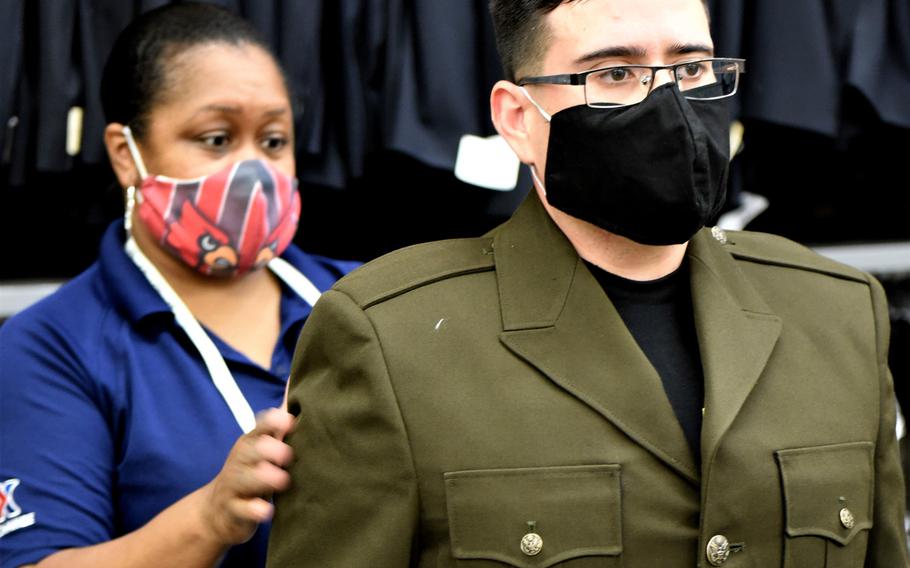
[445,465,622,568]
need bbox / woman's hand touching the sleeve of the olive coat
[201,408,294,545]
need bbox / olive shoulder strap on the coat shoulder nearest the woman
[333,237,493,309]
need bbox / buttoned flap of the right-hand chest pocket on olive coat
[776,442,874,545]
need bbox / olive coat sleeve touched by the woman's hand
[268,291,418,568]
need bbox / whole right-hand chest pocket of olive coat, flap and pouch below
[777,442,874,568]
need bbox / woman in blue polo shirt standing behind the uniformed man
[0,4,353,567]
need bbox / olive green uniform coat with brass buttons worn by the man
[269,194,907,568]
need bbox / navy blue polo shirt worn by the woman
[0,222,357,567]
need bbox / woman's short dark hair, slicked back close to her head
[101,2,278,138]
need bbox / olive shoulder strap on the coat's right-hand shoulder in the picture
[715,231,869,284]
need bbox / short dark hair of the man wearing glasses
[490,0,708,81]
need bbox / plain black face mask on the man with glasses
[545,84,730,245]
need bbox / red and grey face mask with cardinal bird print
[127,131,300,276]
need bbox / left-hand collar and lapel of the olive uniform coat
[494,195,699,483]
